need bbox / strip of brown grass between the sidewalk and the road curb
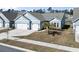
[0,39,66,52]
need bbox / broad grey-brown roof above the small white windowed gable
[42,13,64,21]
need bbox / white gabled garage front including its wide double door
[15,16,30,30]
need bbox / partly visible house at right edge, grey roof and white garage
[72,8,79,42]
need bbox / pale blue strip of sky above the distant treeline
[3,7,73,11]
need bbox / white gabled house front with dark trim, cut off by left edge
[0,12,9,28]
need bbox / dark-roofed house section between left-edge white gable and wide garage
[3,11,18,28]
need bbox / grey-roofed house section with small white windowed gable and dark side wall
[42,13,66,29]
